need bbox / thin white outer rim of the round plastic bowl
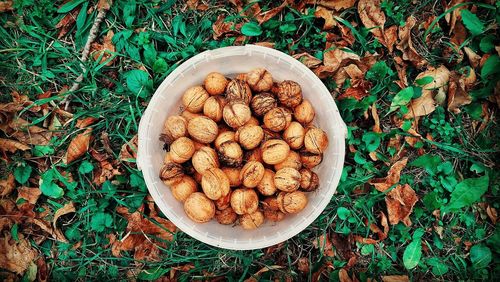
[136,44,347,250]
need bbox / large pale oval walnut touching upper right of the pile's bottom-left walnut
[201,167,230,200]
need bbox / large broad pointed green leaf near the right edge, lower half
[445,175,489,211]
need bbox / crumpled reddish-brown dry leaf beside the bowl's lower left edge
[111,203,176,261]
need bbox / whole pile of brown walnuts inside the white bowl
[160,68,328,229]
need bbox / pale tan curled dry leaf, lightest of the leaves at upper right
[404,66,450,119]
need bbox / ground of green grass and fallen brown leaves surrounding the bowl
[0,0,500,281]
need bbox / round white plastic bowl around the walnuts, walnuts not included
[137,45,346,250]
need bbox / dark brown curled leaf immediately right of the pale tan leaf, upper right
[448,67,476,114]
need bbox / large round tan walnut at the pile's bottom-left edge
[184,192,215,223]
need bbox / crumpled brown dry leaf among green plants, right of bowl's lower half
[385,184,418,226]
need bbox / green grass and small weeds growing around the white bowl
[0,0,500,281]
